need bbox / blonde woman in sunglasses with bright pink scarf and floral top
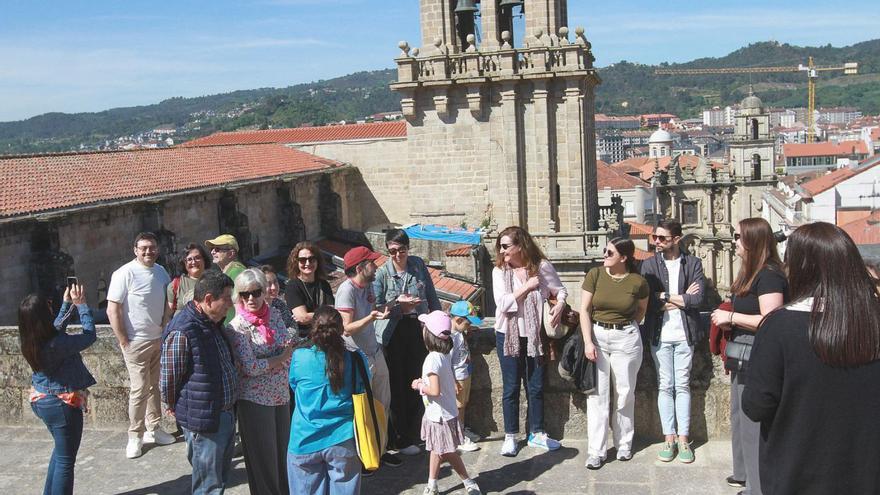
[227,268,295,495]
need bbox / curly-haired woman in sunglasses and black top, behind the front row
[284,241,335,337]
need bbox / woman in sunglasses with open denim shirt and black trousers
[373,229,441,455]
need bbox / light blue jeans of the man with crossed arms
[651,340,694,436]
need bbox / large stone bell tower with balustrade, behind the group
[391,0,604,260]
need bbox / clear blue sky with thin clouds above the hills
[0,0,880,122]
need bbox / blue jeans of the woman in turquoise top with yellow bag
[287,438,361,495]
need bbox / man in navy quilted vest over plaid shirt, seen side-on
[159,272,237,494]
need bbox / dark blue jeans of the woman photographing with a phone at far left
[31,395,83,495]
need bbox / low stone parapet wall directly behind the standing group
[0,326,730,441]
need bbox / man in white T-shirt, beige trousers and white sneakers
[107,232,175,459]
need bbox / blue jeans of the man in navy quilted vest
[182,411,235,495]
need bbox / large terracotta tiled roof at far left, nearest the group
[0,144,342,217]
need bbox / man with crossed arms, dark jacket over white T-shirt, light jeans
[641,220,705,464]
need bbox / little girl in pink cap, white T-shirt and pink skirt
[412,311,482,495]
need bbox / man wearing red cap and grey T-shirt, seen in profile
[336,246,401,467]
